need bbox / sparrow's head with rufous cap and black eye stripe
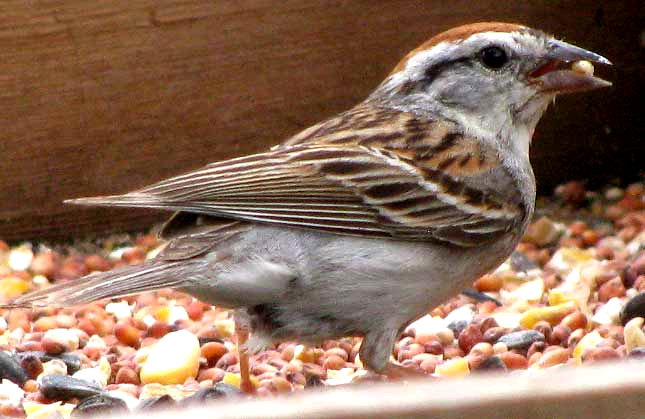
[370,22,611,153]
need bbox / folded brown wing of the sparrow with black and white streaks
[71,106,523,246]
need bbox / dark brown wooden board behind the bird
[0,0,644,240]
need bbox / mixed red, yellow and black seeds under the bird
[0,182,645,419]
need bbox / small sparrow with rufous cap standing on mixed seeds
[6,22,611,391]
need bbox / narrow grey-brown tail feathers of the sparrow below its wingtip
[0,260,199,308]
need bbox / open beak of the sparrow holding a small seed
[529,39,611,94]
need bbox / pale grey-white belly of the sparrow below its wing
[195,226,514,348]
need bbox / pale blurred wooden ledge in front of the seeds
[123,360,645,419]
